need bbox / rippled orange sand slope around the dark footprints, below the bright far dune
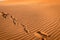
[0,0,60,40]
